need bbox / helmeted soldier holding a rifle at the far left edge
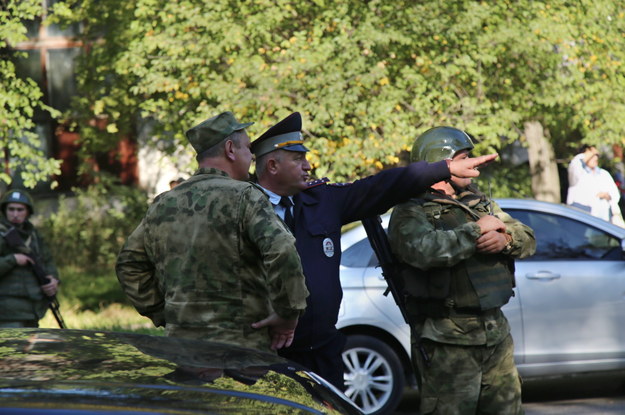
[0,190,59,327]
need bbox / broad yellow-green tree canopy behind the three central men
[51,0,625,199]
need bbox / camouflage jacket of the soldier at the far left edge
[0,218,59,321]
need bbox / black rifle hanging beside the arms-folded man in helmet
[362,216,410,325]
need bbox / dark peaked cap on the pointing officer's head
[252,112,308,157]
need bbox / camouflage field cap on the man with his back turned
[185,111,254,154]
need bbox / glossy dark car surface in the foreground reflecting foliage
[0,329,359,415]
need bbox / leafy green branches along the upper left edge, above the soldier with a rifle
[0,0,61,188]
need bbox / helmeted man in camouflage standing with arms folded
[389,127,536,414]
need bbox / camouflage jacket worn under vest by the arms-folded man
[389,187,536,346]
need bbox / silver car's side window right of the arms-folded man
[506,209,621,261]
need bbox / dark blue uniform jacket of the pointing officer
[291,161,450,350]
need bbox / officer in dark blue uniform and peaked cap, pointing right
[252,112,496,389]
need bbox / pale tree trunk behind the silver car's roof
[524,121,560,203]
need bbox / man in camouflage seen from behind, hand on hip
[116,112,308,350]
